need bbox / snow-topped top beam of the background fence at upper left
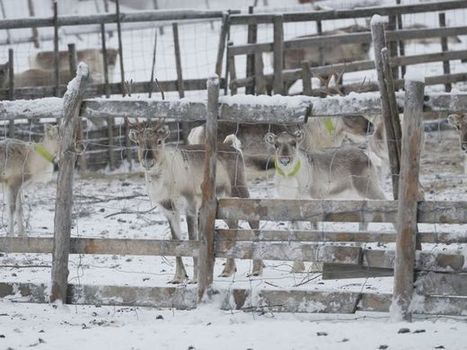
[0,9,229,29]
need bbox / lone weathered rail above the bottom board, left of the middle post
[0,237,199,256]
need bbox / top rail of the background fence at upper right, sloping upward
[230,0,467,25]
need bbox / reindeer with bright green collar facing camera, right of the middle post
[264,130,385,272]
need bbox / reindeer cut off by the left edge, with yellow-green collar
[0,126,58,236]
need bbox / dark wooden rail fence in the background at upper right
[221,1,467,95]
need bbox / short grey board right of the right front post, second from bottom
[415,271,467,297]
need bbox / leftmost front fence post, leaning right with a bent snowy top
[50,63,89,303]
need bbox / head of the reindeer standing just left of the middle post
[128,121,170,171]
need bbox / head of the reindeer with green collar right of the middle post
[264,130,303,175]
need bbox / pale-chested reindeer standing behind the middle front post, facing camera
[129,122,263,283]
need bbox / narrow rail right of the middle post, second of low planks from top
[216,229,467,244]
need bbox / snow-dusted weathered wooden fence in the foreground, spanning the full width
[0,63,467,318]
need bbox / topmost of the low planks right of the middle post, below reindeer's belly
[217,198,467,224]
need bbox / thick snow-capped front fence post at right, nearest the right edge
[391,76,425,321]
